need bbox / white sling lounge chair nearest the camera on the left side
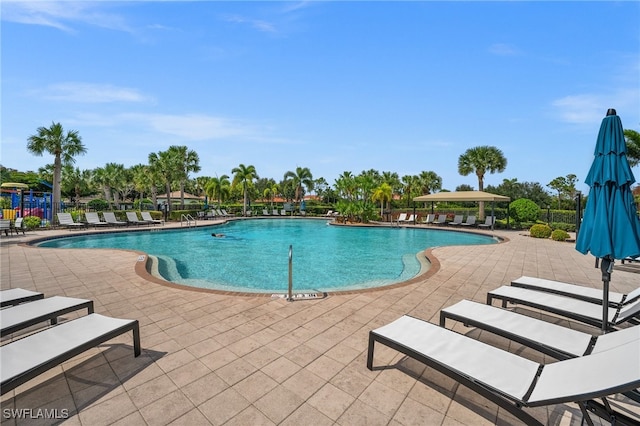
[0,314,141,395]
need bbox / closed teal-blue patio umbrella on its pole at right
[576,109,640,332]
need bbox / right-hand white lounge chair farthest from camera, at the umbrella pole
[487,286,640,330]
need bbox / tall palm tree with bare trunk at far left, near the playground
[27,123,87,213]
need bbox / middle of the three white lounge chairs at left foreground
[0,296,93,337]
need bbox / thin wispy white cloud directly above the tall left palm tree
[35,82,152,103]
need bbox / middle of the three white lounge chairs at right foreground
[440,300,640,359]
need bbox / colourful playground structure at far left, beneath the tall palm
[0,182,53,222]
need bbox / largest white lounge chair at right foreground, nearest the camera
[367,316,640,425]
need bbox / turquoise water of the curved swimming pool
[40,219,497,293]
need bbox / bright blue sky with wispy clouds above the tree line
[0,0,640,193]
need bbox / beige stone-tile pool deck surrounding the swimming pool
[0,219,640,426]
